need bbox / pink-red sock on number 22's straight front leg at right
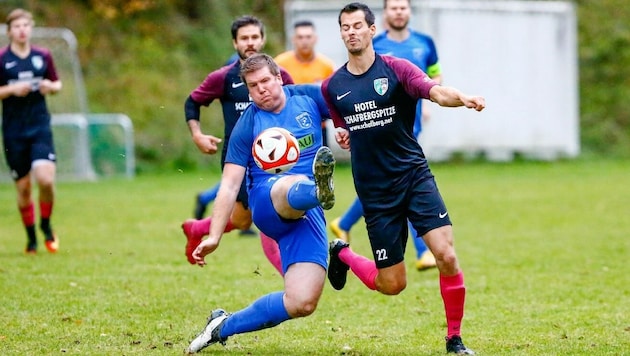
[440,271,466,338]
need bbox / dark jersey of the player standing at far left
[0,46,59,138]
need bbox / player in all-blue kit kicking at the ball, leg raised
[188,54,335,352]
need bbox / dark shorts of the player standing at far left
[4,126,56,180]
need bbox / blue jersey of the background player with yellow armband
[372,29,441,137]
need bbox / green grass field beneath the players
[0,159,630,355]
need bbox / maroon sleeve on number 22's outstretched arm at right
[381,56,438,99]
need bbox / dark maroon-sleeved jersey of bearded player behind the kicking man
[190,60,293,162]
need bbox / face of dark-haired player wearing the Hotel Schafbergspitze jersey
[340,10,376,54]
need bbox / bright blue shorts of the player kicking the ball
[249,175,328,272]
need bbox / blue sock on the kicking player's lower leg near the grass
[220,292,291,338]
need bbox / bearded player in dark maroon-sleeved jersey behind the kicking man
[182,16,293,272]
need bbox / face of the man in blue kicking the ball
[245,66,284,112]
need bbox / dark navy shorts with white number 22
[365,176,451,268]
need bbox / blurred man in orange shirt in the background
[275,20,335,146]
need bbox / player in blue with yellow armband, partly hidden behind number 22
[330,0,442,271]
